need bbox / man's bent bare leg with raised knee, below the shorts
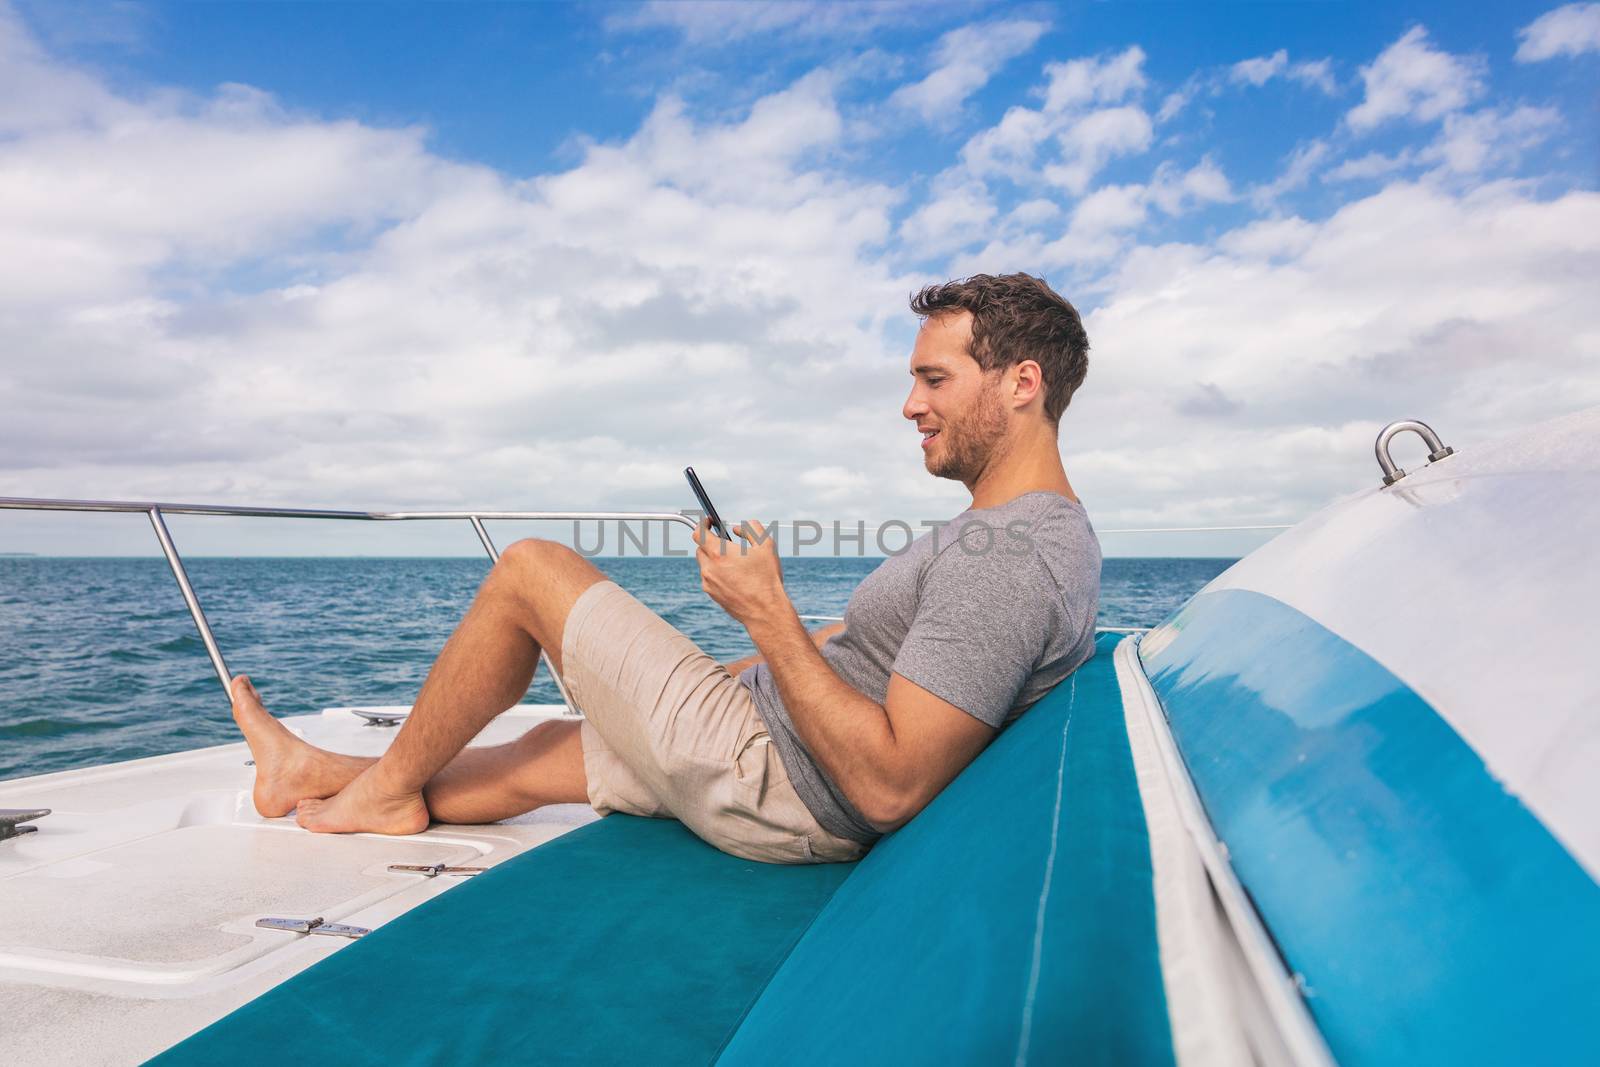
[236,541,605,833]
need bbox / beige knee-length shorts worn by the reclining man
[562,581,867,864]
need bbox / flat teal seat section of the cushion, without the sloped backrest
[154,814,853,1067]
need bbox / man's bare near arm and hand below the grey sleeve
[696,523,997,832]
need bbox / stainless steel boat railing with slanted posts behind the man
[0,496,696,712]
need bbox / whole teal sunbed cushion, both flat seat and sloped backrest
[157,638,1171,1067]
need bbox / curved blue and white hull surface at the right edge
[1125,411,1600,1064]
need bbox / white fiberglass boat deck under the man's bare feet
[0,705,595,1064]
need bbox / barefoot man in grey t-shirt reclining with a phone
[234,274,1101,862]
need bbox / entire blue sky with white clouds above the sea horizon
[0,2,1600,553]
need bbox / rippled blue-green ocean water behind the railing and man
[0,557,1232,779]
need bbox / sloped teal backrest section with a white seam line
[722,635,1173,1064]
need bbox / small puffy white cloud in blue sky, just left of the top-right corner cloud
[1344,26,1483,133]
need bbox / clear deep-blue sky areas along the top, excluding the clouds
[43,3,1597,219]
